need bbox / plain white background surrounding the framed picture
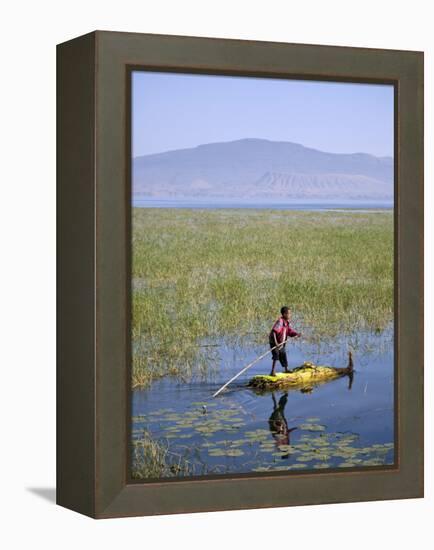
[0,0,434,550]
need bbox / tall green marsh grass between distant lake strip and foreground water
[132,208,393,387]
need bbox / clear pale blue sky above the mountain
[132,71,393,156]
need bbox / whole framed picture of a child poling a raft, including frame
[57,31,423,518]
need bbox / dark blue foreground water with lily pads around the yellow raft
[132,329,394,476]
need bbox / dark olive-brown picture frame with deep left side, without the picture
[57,31,423,518]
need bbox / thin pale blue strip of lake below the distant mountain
[133,197,393,211]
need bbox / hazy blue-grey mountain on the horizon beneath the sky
[133,138,393,200]
